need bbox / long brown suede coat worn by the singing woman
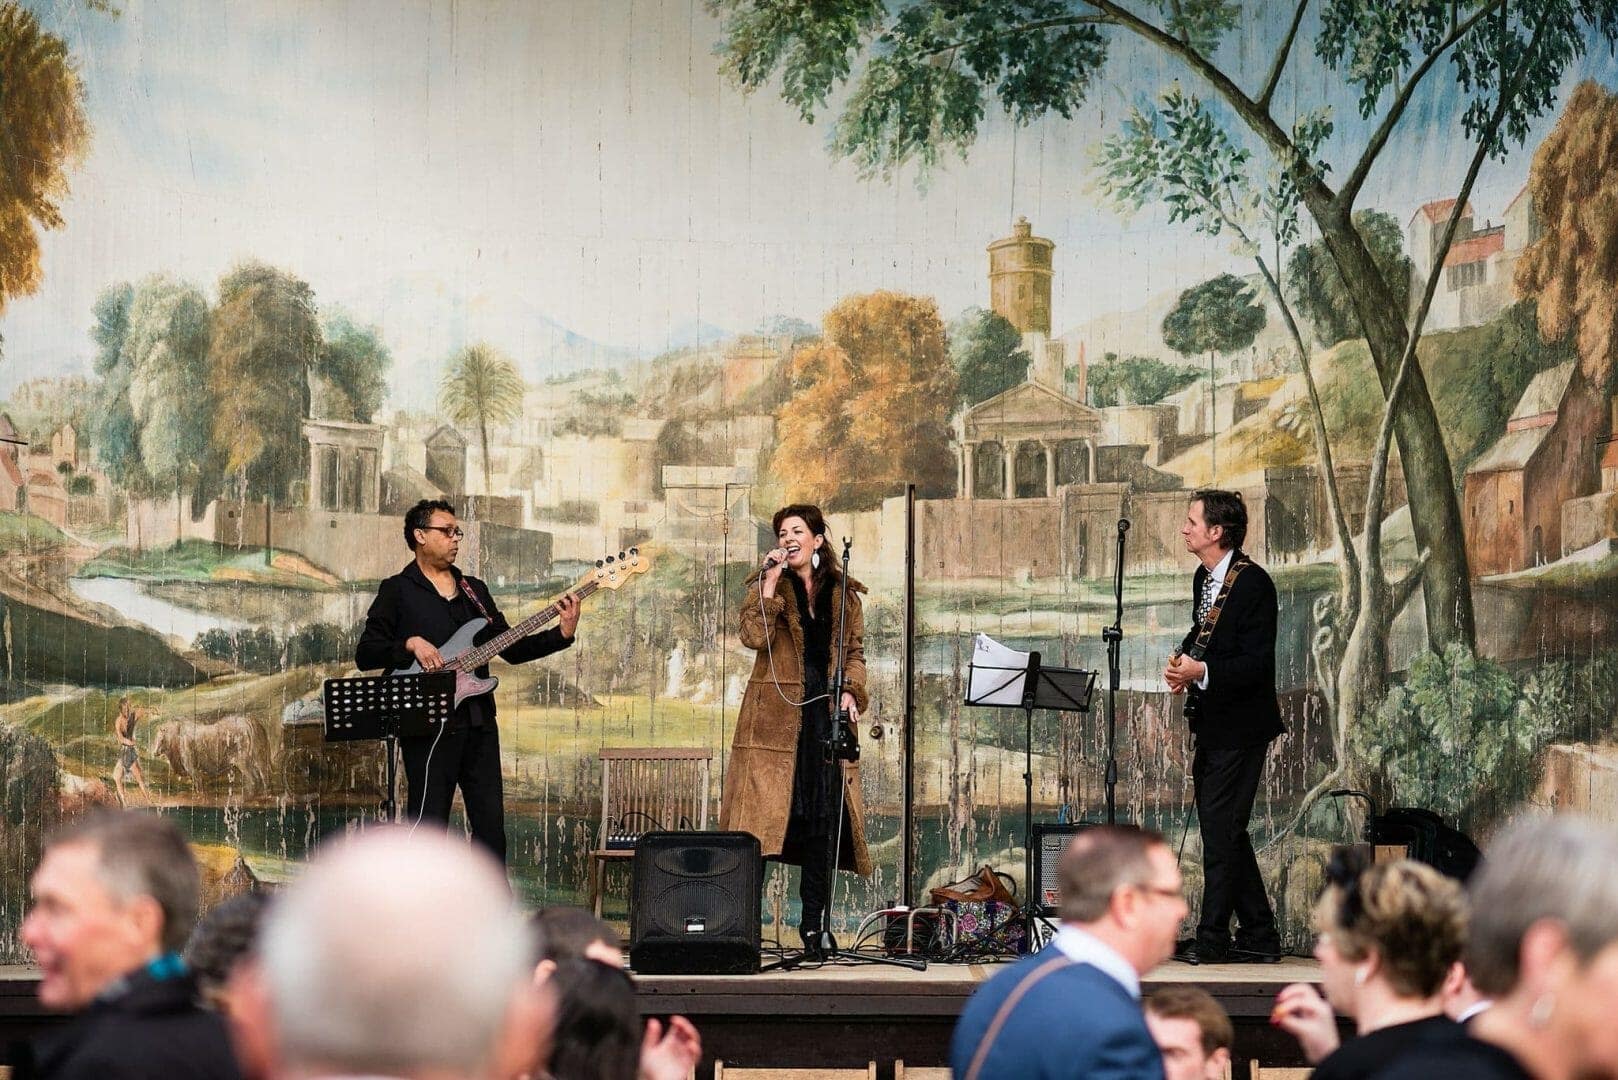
[718,573,872,874]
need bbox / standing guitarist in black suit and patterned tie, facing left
[1163,489,1285,963]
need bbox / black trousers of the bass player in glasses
[400,722,505,866]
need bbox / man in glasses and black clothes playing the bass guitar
[354,499,579,863]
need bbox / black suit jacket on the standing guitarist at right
[1181,552,1286,750]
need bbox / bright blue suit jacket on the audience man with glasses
[950,947,1163,1080]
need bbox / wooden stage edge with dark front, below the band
[0,959,1320,1080]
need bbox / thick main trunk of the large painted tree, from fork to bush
[1311,208,1476,654]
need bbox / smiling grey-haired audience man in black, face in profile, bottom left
[21,811,239,1080]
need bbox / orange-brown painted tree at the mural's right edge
[1516,83,1618,392]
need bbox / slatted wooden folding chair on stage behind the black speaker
[591,746,714,918]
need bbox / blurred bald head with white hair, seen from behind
[236,831,550,1080]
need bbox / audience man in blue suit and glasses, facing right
[950,826,1189,1080]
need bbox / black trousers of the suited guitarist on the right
[1191,746,1281,952]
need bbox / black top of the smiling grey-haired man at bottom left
[21,970,241,1080]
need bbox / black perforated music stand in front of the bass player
[320,670,455,821]
